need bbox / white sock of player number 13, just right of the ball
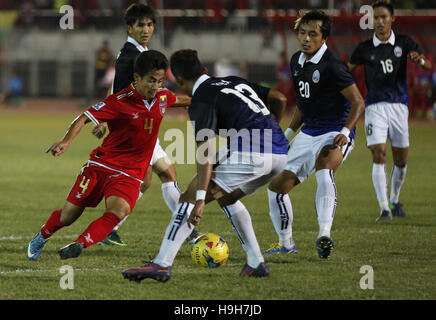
[222,201,264,268]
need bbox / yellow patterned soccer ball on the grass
[191,233,229,268]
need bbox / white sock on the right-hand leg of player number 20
[315,169,337,237]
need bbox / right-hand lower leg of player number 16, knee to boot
[389,147,409,218]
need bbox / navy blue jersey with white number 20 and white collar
[290,44,355,138]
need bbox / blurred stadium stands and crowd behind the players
[0,0,436,119]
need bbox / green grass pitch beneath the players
[0,114,436,300]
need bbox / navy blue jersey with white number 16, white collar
[350,33,421,106]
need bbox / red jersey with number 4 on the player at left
[84,84,176,180]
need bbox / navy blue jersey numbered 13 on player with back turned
[189,75,288,154]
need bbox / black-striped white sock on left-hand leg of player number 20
[267,189,294,249]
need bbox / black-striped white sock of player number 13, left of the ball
[153,202,194,267]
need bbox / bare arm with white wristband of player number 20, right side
[333,83,365,147]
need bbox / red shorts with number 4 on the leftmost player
[67,163,141,211]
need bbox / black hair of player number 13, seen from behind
[170,49,205,80]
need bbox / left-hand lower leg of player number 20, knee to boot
[262,170,300,254]
